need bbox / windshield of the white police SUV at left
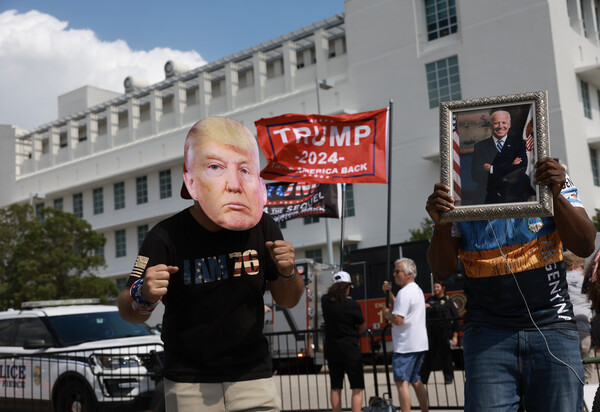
[47,312,153,345]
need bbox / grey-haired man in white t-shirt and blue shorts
[383,258,429,412]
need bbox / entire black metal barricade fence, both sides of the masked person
[0,330,464,412]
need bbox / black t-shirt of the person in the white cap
[321,295,365,361]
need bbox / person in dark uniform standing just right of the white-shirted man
[421,280,458,385]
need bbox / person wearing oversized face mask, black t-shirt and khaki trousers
[118,117,304,412]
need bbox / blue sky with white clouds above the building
[0,0,344,128]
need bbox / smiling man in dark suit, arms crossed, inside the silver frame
[471,110,535,203]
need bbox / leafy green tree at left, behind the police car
[0,204,118,309]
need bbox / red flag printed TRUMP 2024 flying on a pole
[254,108,388,183]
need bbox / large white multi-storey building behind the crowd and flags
[0,0,600,284]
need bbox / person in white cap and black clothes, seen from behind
[321,271,367,412]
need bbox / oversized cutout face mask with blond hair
[181,117,266,230]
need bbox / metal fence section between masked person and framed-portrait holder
[266,328,464,411]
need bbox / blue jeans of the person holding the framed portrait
[463,326,584,412]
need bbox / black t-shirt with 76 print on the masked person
[127,209,283,382]
